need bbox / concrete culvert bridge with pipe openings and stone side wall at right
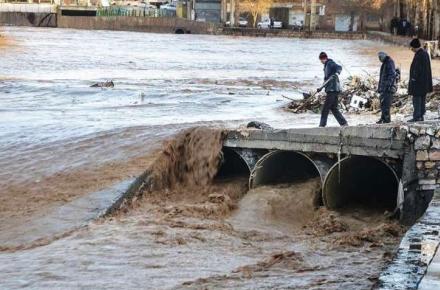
[219,123,440,290]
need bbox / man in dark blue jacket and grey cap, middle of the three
[377,52,397,124]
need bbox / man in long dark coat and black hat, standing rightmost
[408,38,433,122]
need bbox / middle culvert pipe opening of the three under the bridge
[250,151,320,188]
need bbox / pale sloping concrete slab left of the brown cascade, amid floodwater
[0,179,135,249]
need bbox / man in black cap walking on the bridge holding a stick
[318,52,347,127]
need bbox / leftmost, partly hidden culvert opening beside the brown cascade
[217,147,251,178]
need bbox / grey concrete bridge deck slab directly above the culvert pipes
[224,126,407,158]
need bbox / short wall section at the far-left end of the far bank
[0,12,57,27]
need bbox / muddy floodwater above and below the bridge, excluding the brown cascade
[0,27,414,289]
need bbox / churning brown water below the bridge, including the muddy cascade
[0,128,402,289]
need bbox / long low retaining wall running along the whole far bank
[0,12,416,40]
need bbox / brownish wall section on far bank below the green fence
[58,16,216,34]
